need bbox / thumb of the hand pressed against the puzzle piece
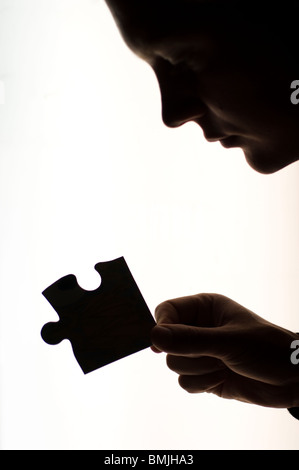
[151,324,232,359]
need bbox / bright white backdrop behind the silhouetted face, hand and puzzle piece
[0,0,299,450]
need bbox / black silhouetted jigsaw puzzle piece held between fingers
[41,257,156,374]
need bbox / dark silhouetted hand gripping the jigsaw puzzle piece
[152,294,299,408]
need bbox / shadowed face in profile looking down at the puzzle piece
[108,0,299,173]
